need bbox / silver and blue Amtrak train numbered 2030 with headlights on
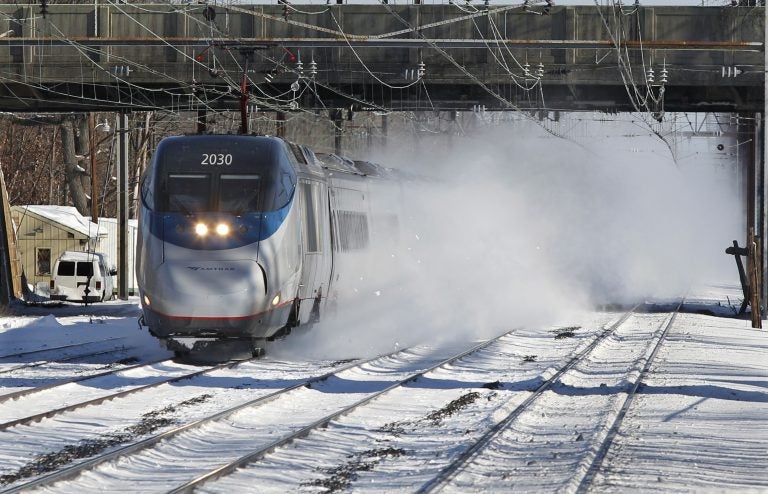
[136,135,400,354]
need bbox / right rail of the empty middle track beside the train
[168,330,514,494]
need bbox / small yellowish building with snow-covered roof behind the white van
[11,205,107,294]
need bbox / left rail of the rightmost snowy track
[416,304,640,494]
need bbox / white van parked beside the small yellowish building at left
[51,251,117,302]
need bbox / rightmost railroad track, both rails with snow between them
[416,301,683,494]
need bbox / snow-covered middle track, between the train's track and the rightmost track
[3,328,524,493]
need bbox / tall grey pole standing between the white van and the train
[117,112,133,300]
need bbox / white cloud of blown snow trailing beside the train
[278,117,744,358]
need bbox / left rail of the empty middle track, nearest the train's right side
[0,354,392,494]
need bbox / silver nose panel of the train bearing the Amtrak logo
[155,260,267,317]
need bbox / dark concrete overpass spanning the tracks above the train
[0,0,764,112]
